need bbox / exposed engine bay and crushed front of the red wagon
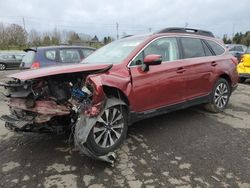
[1,74,93,134]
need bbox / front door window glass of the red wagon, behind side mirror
[131,38,179,66]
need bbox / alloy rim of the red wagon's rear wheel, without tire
[214,83,229,108]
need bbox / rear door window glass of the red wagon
[181,38,206,58]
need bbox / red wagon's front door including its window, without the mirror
[130,37,185,112]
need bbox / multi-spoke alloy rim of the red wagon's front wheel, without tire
[93,107,124,148]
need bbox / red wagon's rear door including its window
[180,37,216,99]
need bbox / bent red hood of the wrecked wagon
[8,64,112,80]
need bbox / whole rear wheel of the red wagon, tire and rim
[204,78,231,113]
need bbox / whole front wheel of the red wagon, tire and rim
[86,105,128,156]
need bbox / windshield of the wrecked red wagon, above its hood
[81,37,145,64]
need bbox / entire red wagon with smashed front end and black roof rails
[1,28,238,162]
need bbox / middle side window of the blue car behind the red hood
[59,49,81,63]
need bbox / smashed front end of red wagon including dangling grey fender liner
[0,67,125,162]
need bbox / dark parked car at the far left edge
[0,54,24,70]
